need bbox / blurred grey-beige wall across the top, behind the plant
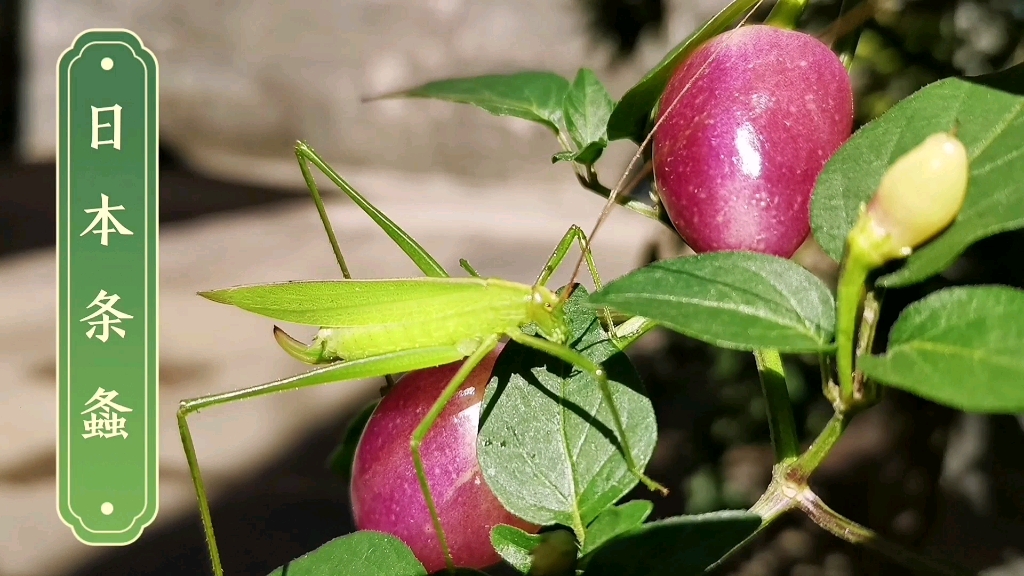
[19,0,727,183]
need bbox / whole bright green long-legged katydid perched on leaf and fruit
[177,142,667,576]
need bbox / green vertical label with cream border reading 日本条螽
[57,30,159,545]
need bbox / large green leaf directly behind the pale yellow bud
[811,72,1024,287]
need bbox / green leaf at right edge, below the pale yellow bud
[857,286,1024,414]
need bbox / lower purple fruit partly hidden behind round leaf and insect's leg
[352,342,539,572]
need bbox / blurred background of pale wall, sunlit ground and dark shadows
[0,0,1024,576]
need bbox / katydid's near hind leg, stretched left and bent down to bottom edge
[177,346,465,576]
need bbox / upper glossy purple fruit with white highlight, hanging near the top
[653,26,853,257]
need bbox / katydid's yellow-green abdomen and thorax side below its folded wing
[317,281,530,360]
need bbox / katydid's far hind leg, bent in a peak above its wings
[295,142,449,278]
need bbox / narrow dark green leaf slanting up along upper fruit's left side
[608,0,761,143]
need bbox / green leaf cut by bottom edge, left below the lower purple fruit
[269,530,427,576]
